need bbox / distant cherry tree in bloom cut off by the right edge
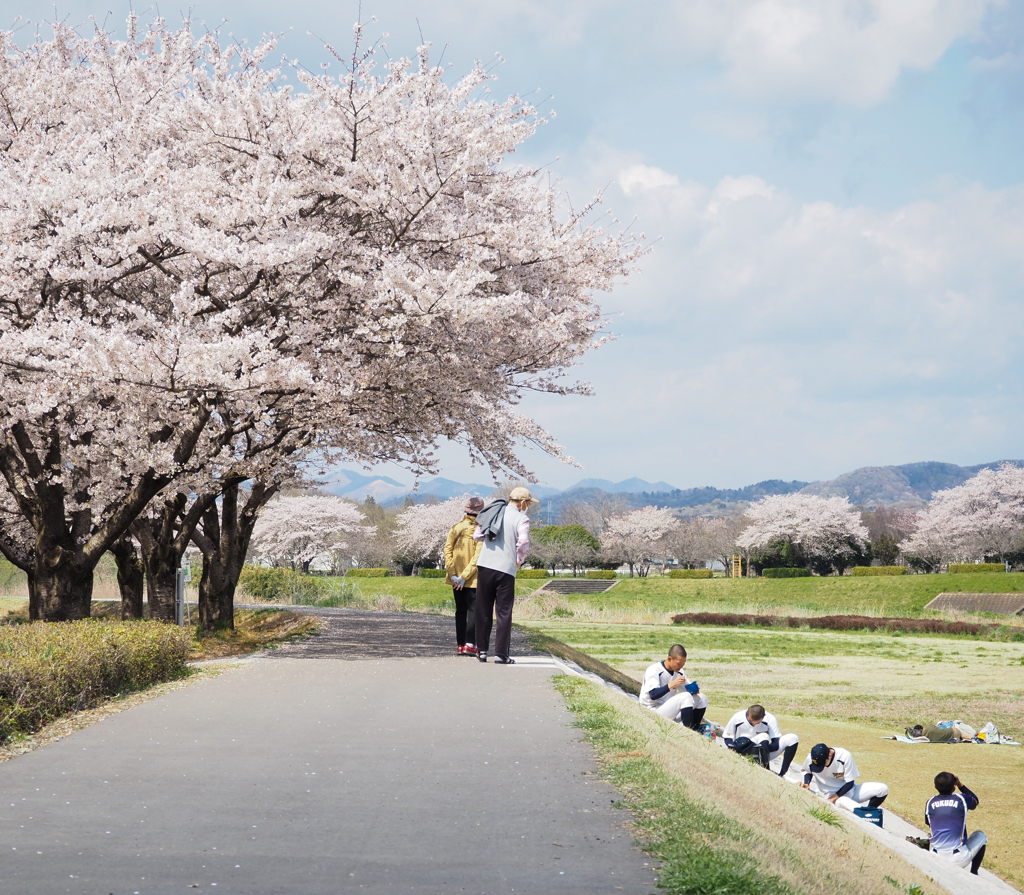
[903,463,1024,569]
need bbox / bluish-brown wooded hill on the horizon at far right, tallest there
[802,460,1024,507]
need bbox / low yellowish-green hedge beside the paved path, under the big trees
[0,619,191,740]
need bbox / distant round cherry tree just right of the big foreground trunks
[249,494,368,572]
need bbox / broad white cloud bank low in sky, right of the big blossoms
[507,154,1024,486]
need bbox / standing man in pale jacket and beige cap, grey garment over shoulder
[473,487,538,665]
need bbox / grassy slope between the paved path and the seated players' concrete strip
[556,677,937,895]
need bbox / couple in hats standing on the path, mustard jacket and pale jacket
[444,487,538,665]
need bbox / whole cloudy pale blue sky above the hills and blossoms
[8,0,1024,487]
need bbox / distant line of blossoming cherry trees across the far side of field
[245,464,1024,576]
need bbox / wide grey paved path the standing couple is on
[0,611,654,895]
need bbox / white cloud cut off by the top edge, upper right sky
[675,0,1004,106]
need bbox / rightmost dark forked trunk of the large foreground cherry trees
[193,482,279,630]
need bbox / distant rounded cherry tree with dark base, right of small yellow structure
[736,494,867,574]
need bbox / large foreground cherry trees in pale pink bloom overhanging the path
[0,14,641,626]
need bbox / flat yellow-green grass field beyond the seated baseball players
[522,618,1024,888]
